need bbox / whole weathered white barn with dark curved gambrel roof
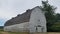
[4,6,47,32]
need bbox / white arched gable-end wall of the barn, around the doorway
[29,7,47,32]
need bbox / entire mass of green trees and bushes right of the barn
[41,1,60,32]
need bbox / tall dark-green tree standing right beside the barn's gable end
[41,1,56,31]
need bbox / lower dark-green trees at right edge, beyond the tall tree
[51,13,60,32]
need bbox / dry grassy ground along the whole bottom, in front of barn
[0,29,60,34]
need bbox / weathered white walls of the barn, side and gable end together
[4,7,47,32]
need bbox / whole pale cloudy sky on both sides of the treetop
[0,0,60,26]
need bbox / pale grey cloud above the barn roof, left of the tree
[0,0,41,19]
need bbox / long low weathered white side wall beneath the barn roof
[4,22,29,32]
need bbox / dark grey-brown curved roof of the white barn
[4,6,40,26]
